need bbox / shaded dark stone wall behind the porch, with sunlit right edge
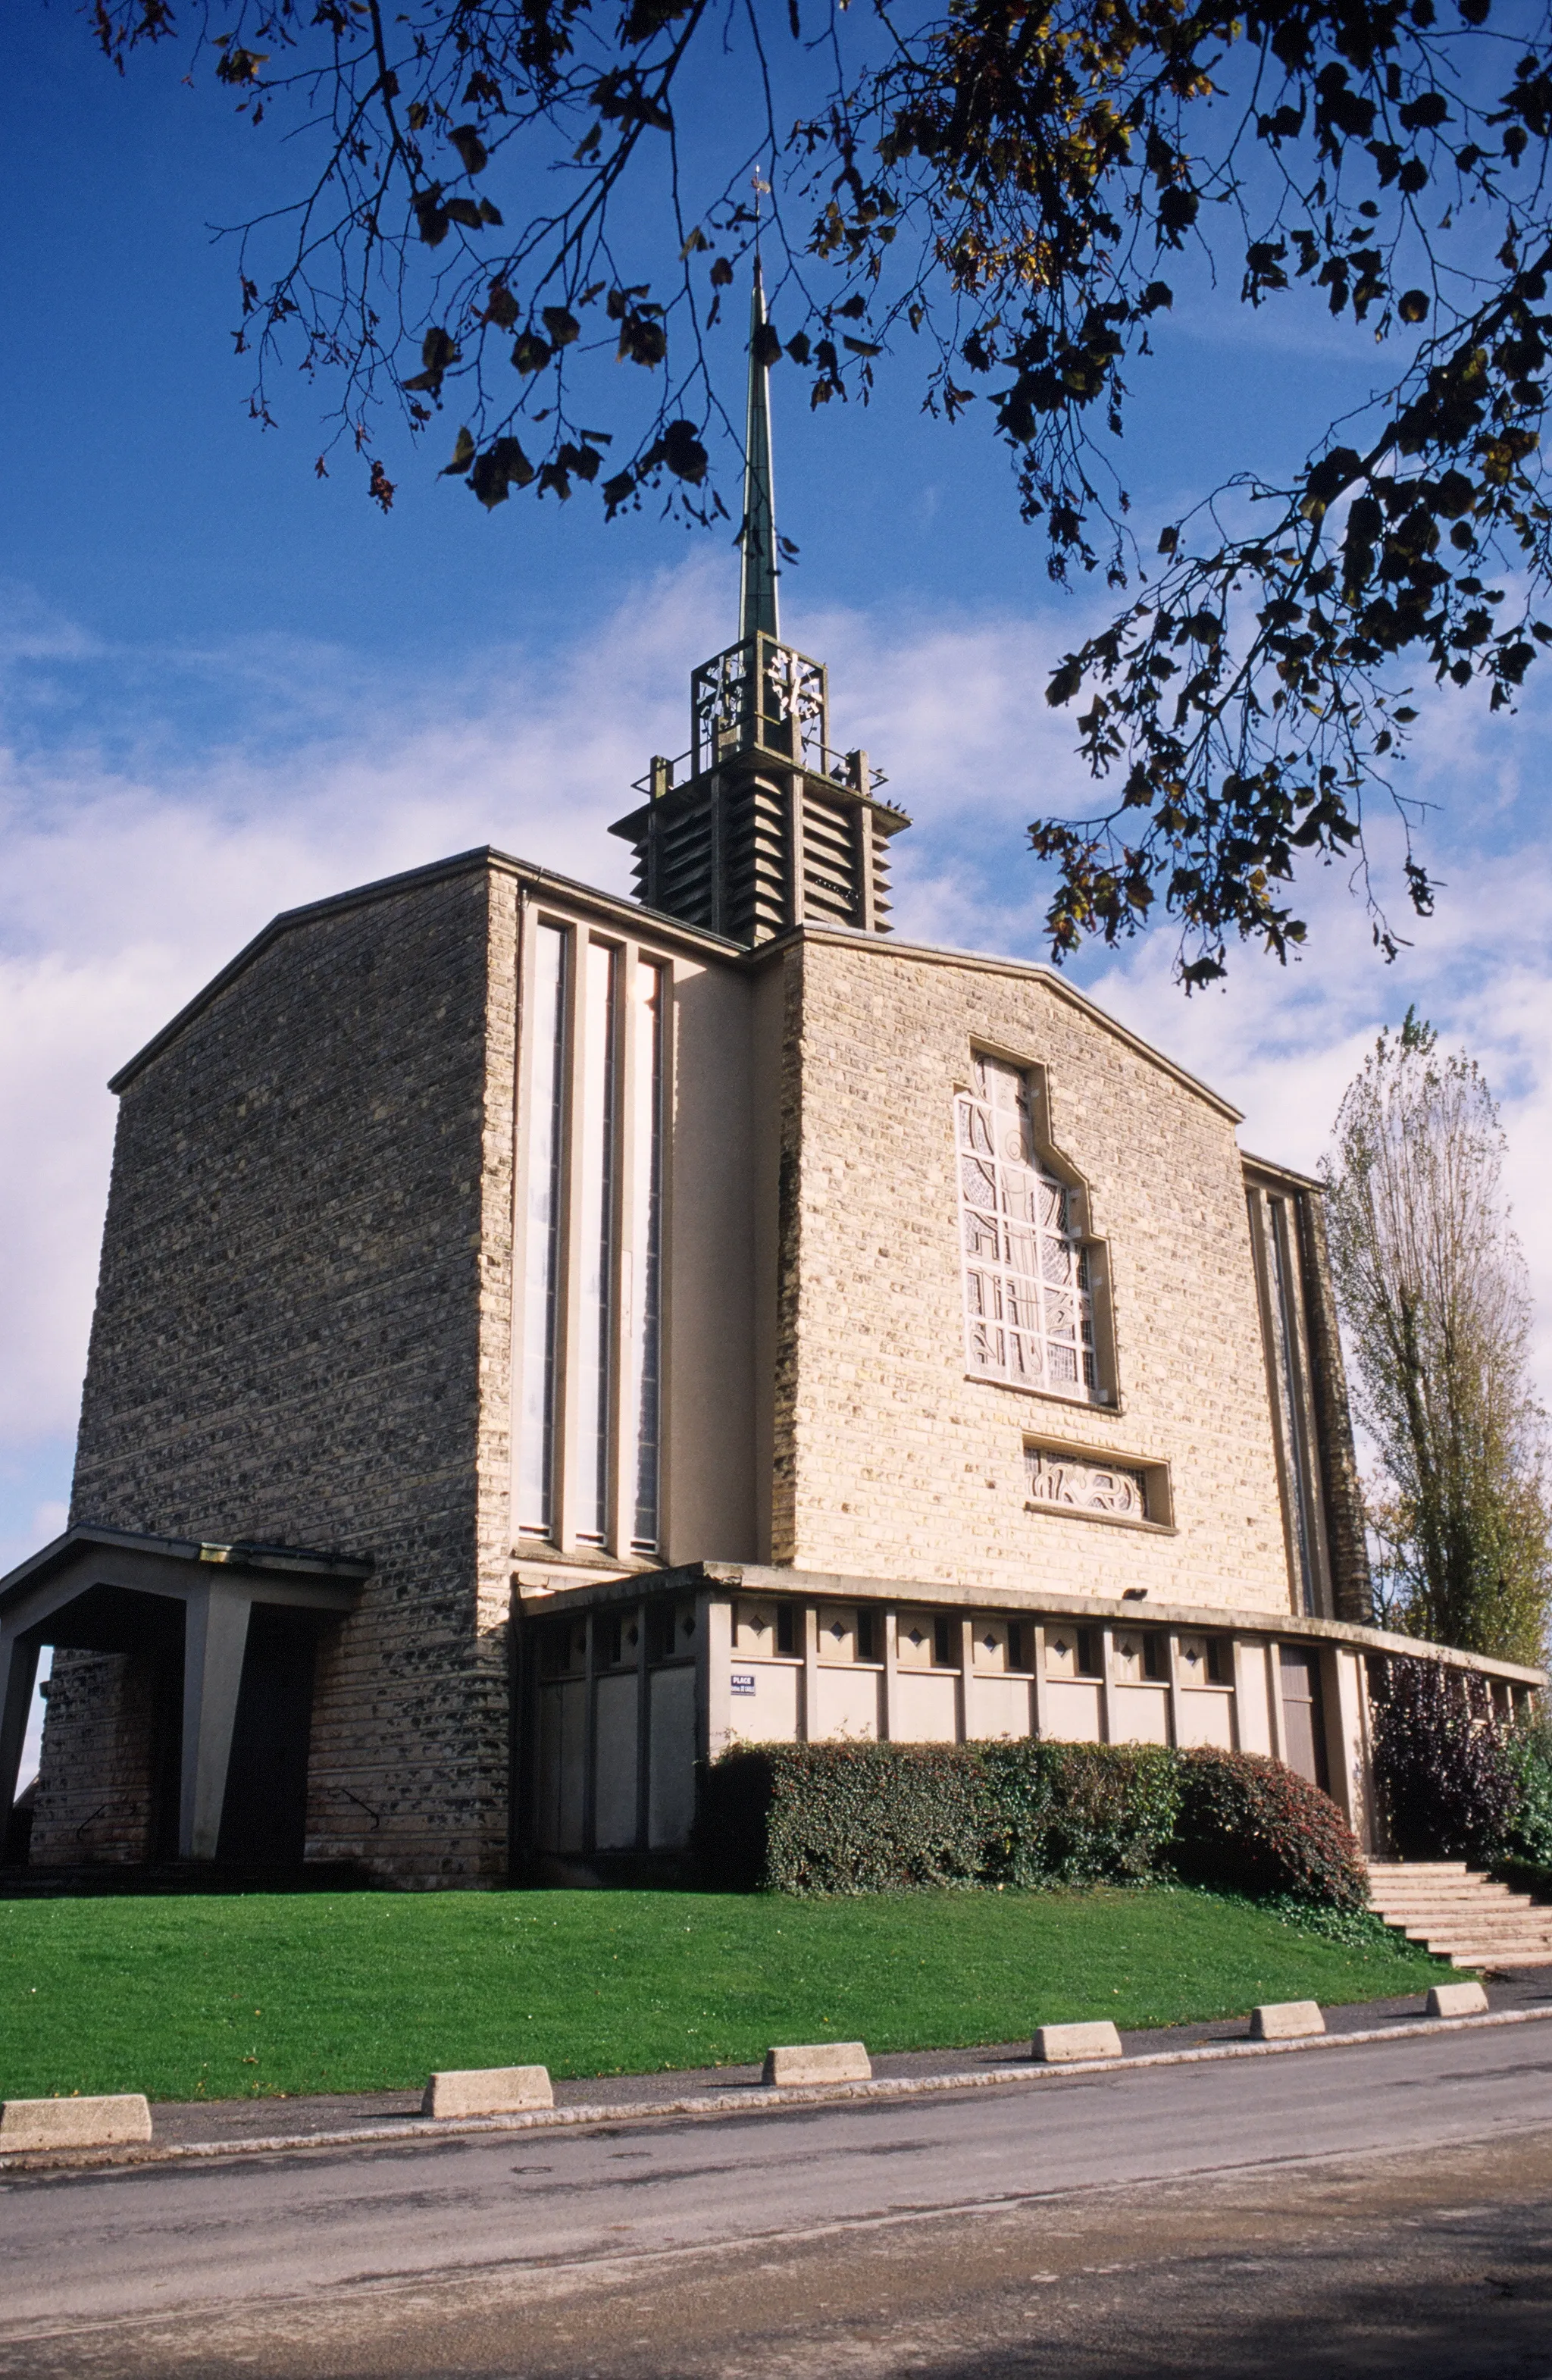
[36,854,514,1883]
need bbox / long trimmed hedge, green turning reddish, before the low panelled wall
[695,1740,1369,1909]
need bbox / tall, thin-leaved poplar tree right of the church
[1323,1009,1552,1661]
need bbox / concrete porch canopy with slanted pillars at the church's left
[0,1520,374,1859]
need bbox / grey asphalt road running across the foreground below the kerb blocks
[0,2023,1552,2380]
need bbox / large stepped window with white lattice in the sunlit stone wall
[955,1057,1100,1397]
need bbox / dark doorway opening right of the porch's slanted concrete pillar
[217,1604,317,1868]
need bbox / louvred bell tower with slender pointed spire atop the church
[609,257,912,942]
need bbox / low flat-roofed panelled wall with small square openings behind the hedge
[524,1566,1545,1866]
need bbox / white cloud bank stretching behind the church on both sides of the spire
[0,564,1552,1523]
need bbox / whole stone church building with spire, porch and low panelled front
[0,274,1545,1885]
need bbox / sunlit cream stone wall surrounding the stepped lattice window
[774,933,1290,1611]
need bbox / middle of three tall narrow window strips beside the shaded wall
[576,942,619,1545]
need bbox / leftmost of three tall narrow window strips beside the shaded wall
[517,925,567,1537]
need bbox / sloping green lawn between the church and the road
[0,1890,1438,2099]
